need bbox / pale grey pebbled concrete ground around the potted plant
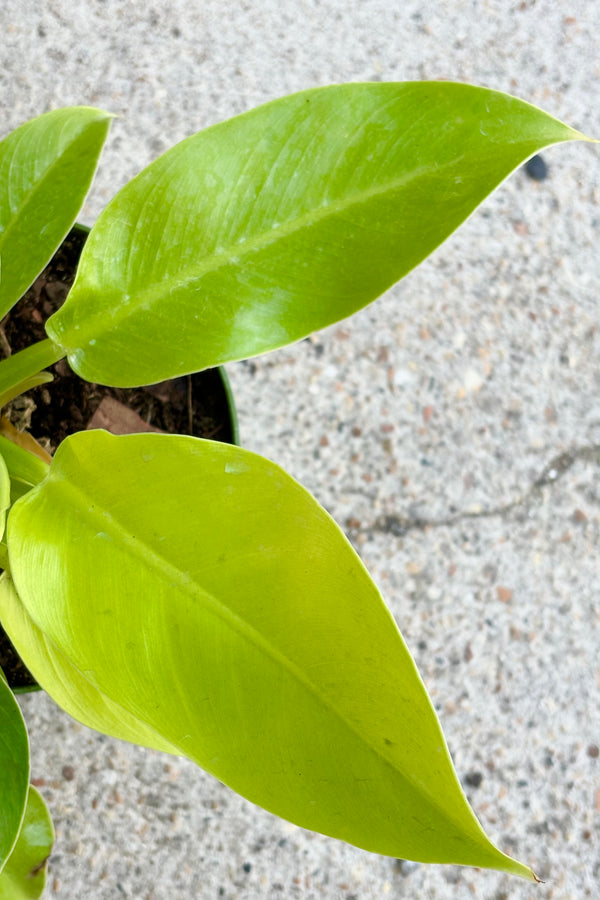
[0,0,600,900]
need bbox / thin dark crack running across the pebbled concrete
[370,444,600,537]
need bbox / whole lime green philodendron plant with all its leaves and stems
[0,82,584,898]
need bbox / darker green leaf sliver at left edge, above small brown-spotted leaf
[0,669,29,872]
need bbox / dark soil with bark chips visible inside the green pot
[0,226,237,691]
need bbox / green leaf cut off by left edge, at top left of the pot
[0,106,111,317]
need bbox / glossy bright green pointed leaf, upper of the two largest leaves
[47,82,582,386]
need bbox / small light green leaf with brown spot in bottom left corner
[0,787,54,900]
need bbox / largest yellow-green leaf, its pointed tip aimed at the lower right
[0,432,533,877]
